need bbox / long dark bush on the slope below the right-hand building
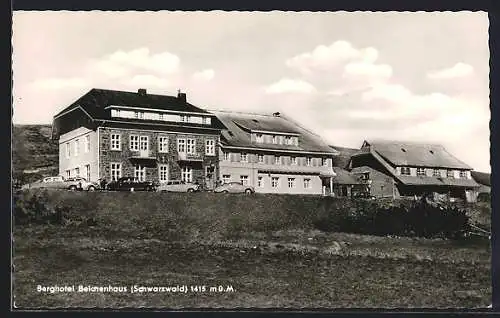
[314,200,469,238]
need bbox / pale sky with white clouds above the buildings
[12,11,491,172]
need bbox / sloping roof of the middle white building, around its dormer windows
[212,111,337,155]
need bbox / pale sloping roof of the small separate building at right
[367,141,472,170]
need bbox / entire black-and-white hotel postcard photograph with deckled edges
[11,10,492,311]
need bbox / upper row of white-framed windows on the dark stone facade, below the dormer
[110,134,215,156]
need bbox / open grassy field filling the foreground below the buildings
[14,193,491,309]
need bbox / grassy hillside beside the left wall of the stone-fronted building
[12,125,58,183]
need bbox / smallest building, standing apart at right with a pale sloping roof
[349,141,479,202]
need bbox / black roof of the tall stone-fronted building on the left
[55,88,210,119]
